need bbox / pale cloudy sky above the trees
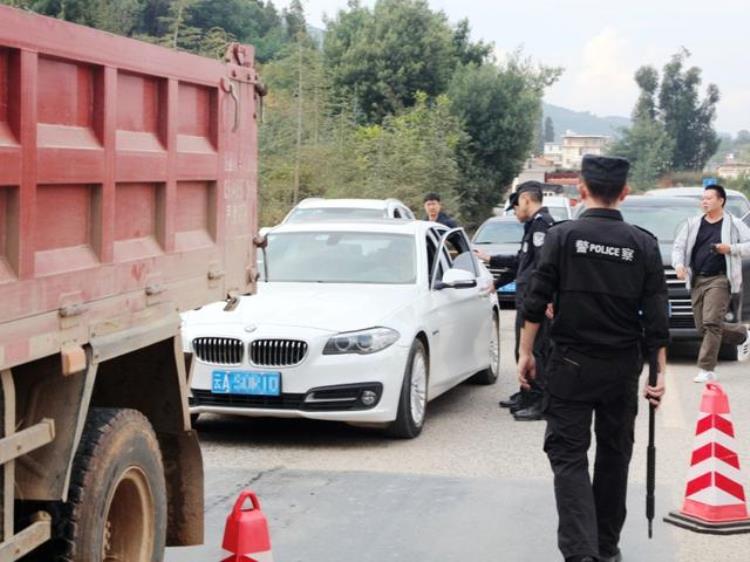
[275,0,750,134]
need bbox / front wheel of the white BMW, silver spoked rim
[388,339,430,439]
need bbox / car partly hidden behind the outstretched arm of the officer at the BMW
[471,215,523,304]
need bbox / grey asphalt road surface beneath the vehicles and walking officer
[166,311,750,562]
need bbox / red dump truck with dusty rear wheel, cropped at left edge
[0,6,263,562]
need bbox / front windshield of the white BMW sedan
[266,232,417,285]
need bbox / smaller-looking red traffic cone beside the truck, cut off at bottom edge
[221,490,273,562]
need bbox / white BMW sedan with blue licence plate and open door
[183,220,500,438]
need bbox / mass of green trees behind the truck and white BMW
[0,0,560,226]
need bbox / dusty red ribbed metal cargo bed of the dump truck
[0,6,259,370]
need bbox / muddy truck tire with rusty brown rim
[53,408,167,562]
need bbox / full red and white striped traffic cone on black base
[664,383,750,535]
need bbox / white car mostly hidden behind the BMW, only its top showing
[281,197,414,224]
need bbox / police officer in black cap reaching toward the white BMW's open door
[475,181,555,421]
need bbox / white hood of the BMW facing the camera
[183,283,417,332]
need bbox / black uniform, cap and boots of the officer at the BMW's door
[490,181,555,420]
